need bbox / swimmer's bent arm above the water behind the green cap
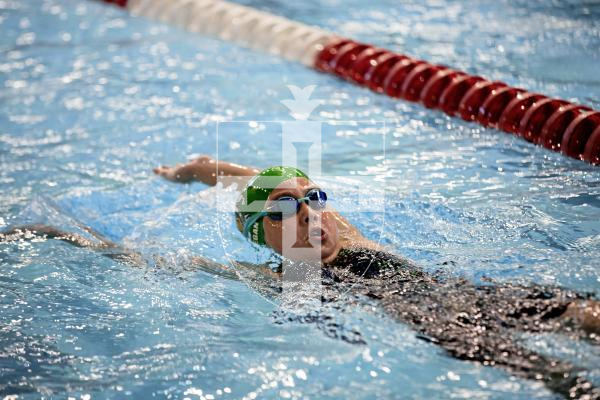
[154,156,260,186]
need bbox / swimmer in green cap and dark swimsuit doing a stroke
[0,156,600,399]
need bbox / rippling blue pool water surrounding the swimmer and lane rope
[0,0,600,399]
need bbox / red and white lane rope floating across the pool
[103,0,600,165]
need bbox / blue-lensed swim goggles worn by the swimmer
[244,189,327,236]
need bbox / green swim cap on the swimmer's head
[235,166,308,245]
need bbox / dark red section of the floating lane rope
[315,39,600,165]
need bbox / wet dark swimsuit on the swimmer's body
[323,248,600,398]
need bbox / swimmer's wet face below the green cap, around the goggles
[263,178,340,262]
